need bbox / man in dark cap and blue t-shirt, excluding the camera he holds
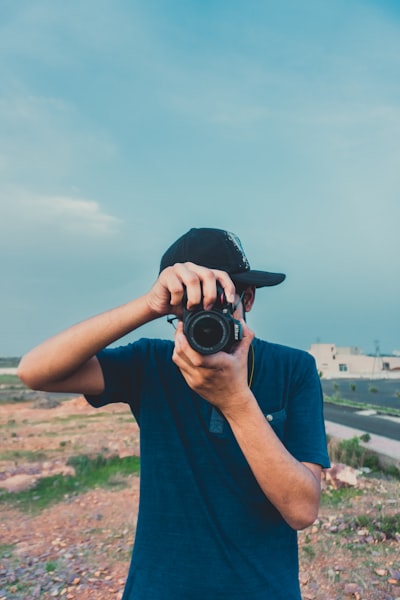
[19,228,329,600]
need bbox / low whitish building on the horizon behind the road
[308,344,400,379]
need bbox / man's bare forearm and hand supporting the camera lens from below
[173,322,321,529]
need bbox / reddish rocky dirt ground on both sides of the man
[0,398,400,600]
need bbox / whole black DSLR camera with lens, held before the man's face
[183,284,243,354]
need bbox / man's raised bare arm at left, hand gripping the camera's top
[18,263,235,395]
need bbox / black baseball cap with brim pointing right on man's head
[160,227,286,288]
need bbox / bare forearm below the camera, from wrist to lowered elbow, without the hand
[225,390,320,529]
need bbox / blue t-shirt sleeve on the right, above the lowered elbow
[285,353,330,468]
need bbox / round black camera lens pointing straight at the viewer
[184,311,231,354]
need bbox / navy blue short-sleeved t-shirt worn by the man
[87,339,329,600]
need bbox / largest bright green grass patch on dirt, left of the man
[0,455,140,513]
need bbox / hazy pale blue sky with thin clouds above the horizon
[0,0,400,356]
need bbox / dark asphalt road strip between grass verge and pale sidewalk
[324,402,400,441]
